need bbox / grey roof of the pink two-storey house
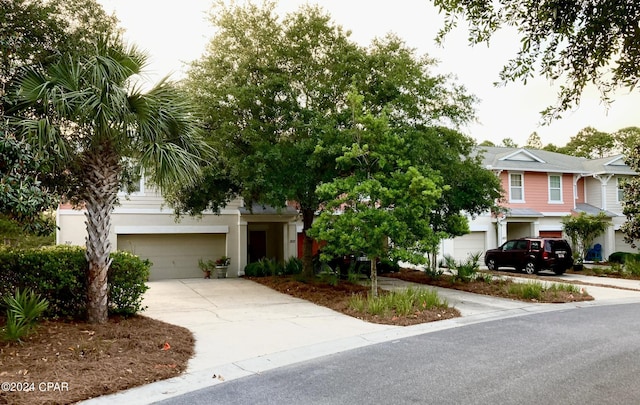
[478,146,637,176]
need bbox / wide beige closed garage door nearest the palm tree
[118,234,225,280]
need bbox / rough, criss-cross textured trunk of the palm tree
[83,147,120,323]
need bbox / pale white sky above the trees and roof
[98,0,640,146]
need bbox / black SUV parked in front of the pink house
[484,238,573,274]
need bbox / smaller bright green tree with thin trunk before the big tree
[310,94,445,296]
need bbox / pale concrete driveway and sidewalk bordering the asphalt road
[82,275,640,404]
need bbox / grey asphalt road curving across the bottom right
[161,304,640,405]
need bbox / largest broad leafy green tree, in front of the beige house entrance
[172,3,484,273]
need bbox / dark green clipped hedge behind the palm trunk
[0,246,151,319]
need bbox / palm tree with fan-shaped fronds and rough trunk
[19,37,209,323]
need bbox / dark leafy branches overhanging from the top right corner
[433,0,640,118]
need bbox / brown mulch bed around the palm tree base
[0,316,195,405]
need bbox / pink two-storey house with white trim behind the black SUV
[440,146,637,260]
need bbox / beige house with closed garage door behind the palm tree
[57,175,298,280]
